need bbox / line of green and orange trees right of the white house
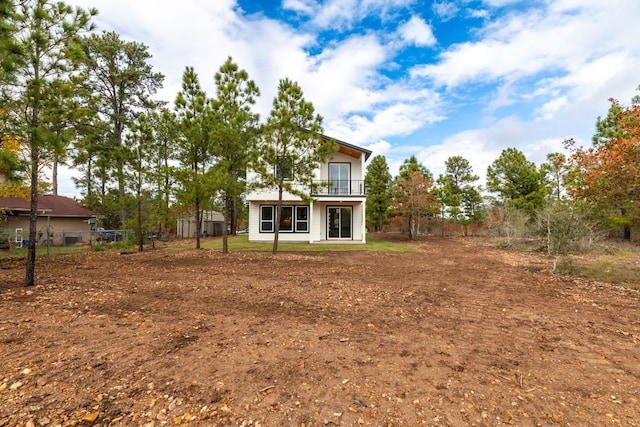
[366,93,640,254]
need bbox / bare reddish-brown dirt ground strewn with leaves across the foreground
[0,239,640,427]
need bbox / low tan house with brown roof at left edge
[0,195,97,245]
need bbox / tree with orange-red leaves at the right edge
[565,100,640,240]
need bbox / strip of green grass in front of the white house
[201,235,418,252]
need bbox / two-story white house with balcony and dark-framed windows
[247,136,371,243]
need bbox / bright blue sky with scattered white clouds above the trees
[61,0,640,194]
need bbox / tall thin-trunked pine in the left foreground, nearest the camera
[11,0,96,286]
